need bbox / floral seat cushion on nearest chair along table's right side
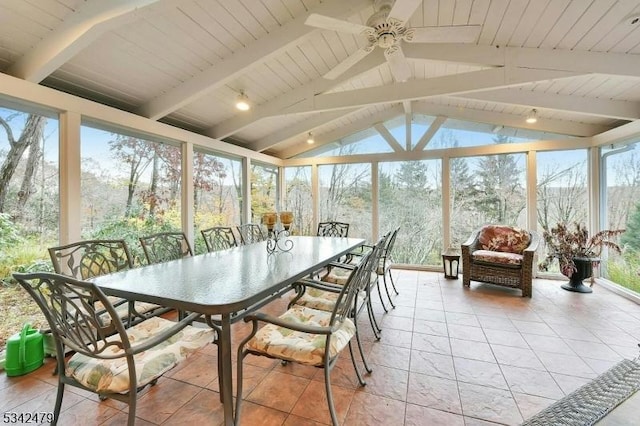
[246,305,356,366]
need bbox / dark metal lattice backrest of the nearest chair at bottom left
[13,273,133,362]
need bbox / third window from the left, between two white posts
[193,151,242,253]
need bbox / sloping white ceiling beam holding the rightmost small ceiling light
[413,101,611,137]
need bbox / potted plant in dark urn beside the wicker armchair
[539,223,624,293]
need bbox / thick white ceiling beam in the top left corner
[6,0,161,83]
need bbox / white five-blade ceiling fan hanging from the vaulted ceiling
[305,0,480,82]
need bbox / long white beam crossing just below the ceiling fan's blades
[298,66,579,114]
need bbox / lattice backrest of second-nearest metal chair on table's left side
[48,240,133,280]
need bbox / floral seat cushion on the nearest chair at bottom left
[66,317,214,393]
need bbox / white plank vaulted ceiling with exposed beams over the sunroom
[0,0,640,158]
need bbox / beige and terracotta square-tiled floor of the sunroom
[0,270,640,426]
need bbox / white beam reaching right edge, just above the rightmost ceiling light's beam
[455,88,640,120]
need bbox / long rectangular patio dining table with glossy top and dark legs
[93,237,364,425]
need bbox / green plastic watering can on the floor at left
[4,323,44,377]
